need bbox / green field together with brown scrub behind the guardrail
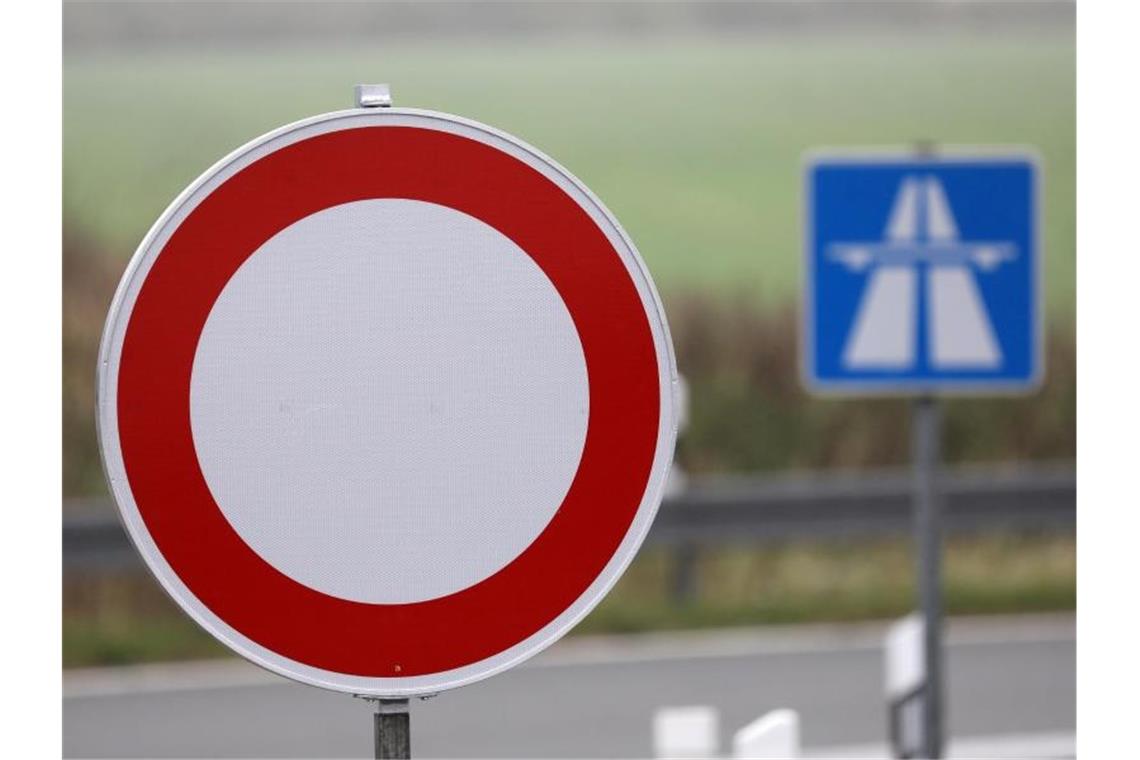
[63,35,1075,496]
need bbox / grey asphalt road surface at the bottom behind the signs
[64,616,1076,758]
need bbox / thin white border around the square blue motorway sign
[799,145,1047,398]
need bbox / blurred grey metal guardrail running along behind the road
[63,466,1076,570]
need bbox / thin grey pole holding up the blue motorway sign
[911,395,943,758]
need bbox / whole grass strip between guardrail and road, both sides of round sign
[63,534,1076,667]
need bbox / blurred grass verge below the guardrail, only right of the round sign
[576,533,1076,634]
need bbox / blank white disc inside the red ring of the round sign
[190,199,589,604]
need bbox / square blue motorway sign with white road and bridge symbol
[801,154,1042,393]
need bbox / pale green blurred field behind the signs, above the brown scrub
[64,35,1075,314]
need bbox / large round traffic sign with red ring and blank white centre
[98,108,676,696]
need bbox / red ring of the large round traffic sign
[117,126,660,678]
